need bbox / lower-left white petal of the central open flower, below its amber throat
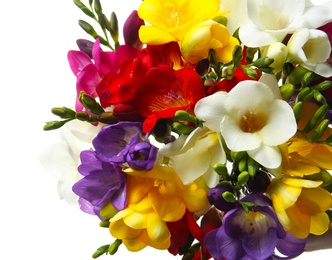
[220,116,262,152]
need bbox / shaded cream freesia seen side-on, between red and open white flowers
[159,127,226,188]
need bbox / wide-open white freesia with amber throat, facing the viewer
[195,75,297,169]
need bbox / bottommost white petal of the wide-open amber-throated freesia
[247,145,281,169]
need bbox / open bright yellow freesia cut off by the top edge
[138,0,222,45]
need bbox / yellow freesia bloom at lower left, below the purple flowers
[109,166,208,251]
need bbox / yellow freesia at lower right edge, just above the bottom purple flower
[267,177,332,238]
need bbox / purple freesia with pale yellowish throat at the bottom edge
[204,193,306,260]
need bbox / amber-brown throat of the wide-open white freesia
[239,111,268,133]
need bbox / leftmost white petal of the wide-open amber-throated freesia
[195,92,227,132]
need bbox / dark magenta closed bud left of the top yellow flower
[123,10,144,49]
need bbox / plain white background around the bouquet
[0,0,332,260]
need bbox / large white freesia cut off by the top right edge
[239,0,332,47]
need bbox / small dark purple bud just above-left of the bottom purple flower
[208,183,235,211]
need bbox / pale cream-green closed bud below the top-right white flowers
[262,42,288,72]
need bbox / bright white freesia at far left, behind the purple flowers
[39,120,100,205]
